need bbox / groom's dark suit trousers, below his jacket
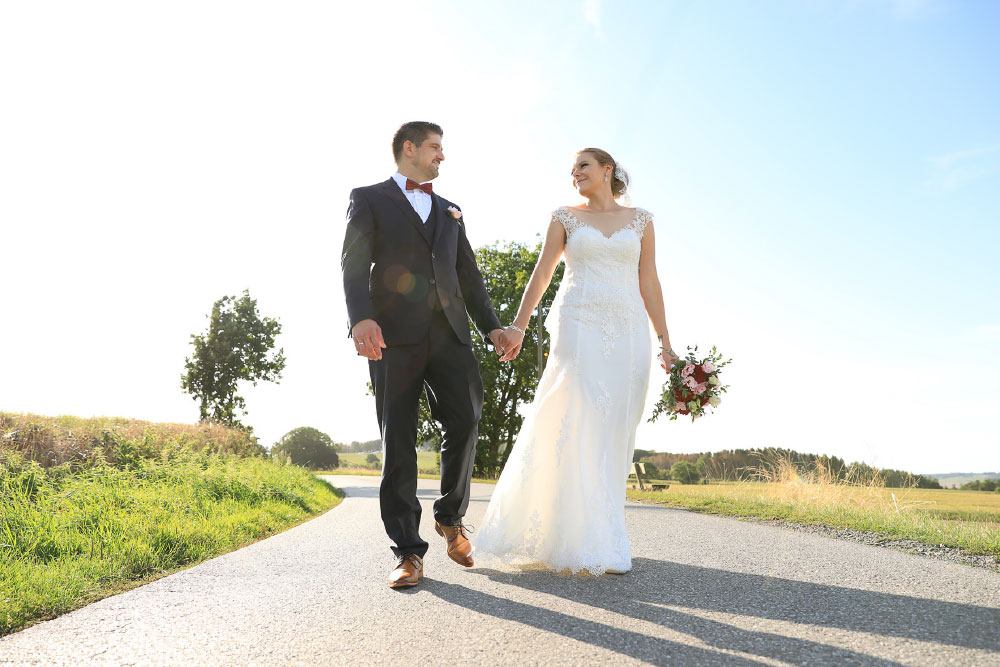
[368,309,483,558]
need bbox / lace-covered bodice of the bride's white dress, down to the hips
[546,206,653,355]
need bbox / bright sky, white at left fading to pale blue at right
[0,0,1000,473]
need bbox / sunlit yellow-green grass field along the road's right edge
[628,479,1000,562]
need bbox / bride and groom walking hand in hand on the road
[341,122,678,588]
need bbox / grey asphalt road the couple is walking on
[0,476,1000,665]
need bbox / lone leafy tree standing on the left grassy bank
[181,290,285,431]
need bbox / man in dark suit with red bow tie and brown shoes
[341,122,506,588]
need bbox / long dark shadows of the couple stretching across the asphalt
[426,558,1000,665]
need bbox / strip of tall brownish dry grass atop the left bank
[0,412,265,468]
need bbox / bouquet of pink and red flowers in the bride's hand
[649,345,732,422]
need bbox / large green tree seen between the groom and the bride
[472,242,564,477]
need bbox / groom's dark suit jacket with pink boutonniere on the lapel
[340,178,502,345]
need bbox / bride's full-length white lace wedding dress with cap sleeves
[474,207,652,575]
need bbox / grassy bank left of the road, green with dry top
[0,413,343,635]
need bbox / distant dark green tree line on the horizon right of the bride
[633,447,944,489]
